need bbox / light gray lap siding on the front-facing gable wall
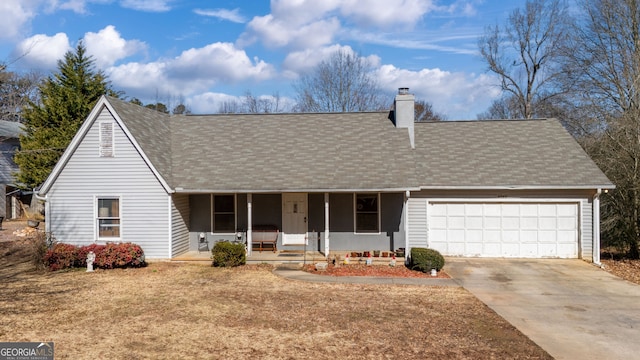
[47,109,171,259]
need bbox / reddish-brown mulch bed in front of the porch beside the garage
[303,264,449,279]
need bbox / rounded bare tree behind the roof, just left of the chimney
[293,50,389,112]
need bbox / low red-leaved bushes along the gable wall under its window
[44,243,146,271]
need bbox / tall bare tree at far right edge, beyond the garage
[566,0,640,258]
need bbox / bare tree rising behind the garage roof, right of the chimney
[478,0,571,119]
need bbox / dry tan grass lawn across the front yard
[0,239,550,359]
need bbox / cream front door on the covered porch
[282,193,307,245]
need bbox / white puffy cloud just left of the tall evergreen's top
[12,33,71,70]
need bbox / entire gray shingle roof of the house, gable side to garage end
[108,98,612,192]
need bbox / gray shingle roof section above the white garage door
[415,119,612,188]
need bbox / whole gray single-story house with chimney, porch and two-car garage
[38,90,614,263]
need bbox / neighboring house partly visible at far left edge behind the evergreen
[0,120,23,219]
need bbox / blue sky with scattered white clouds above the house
[0,0,524,119]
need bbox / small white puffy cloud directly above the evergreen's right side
[84,25,146,69]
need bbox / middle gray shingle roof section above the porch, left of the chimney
[172,113,415,191]
